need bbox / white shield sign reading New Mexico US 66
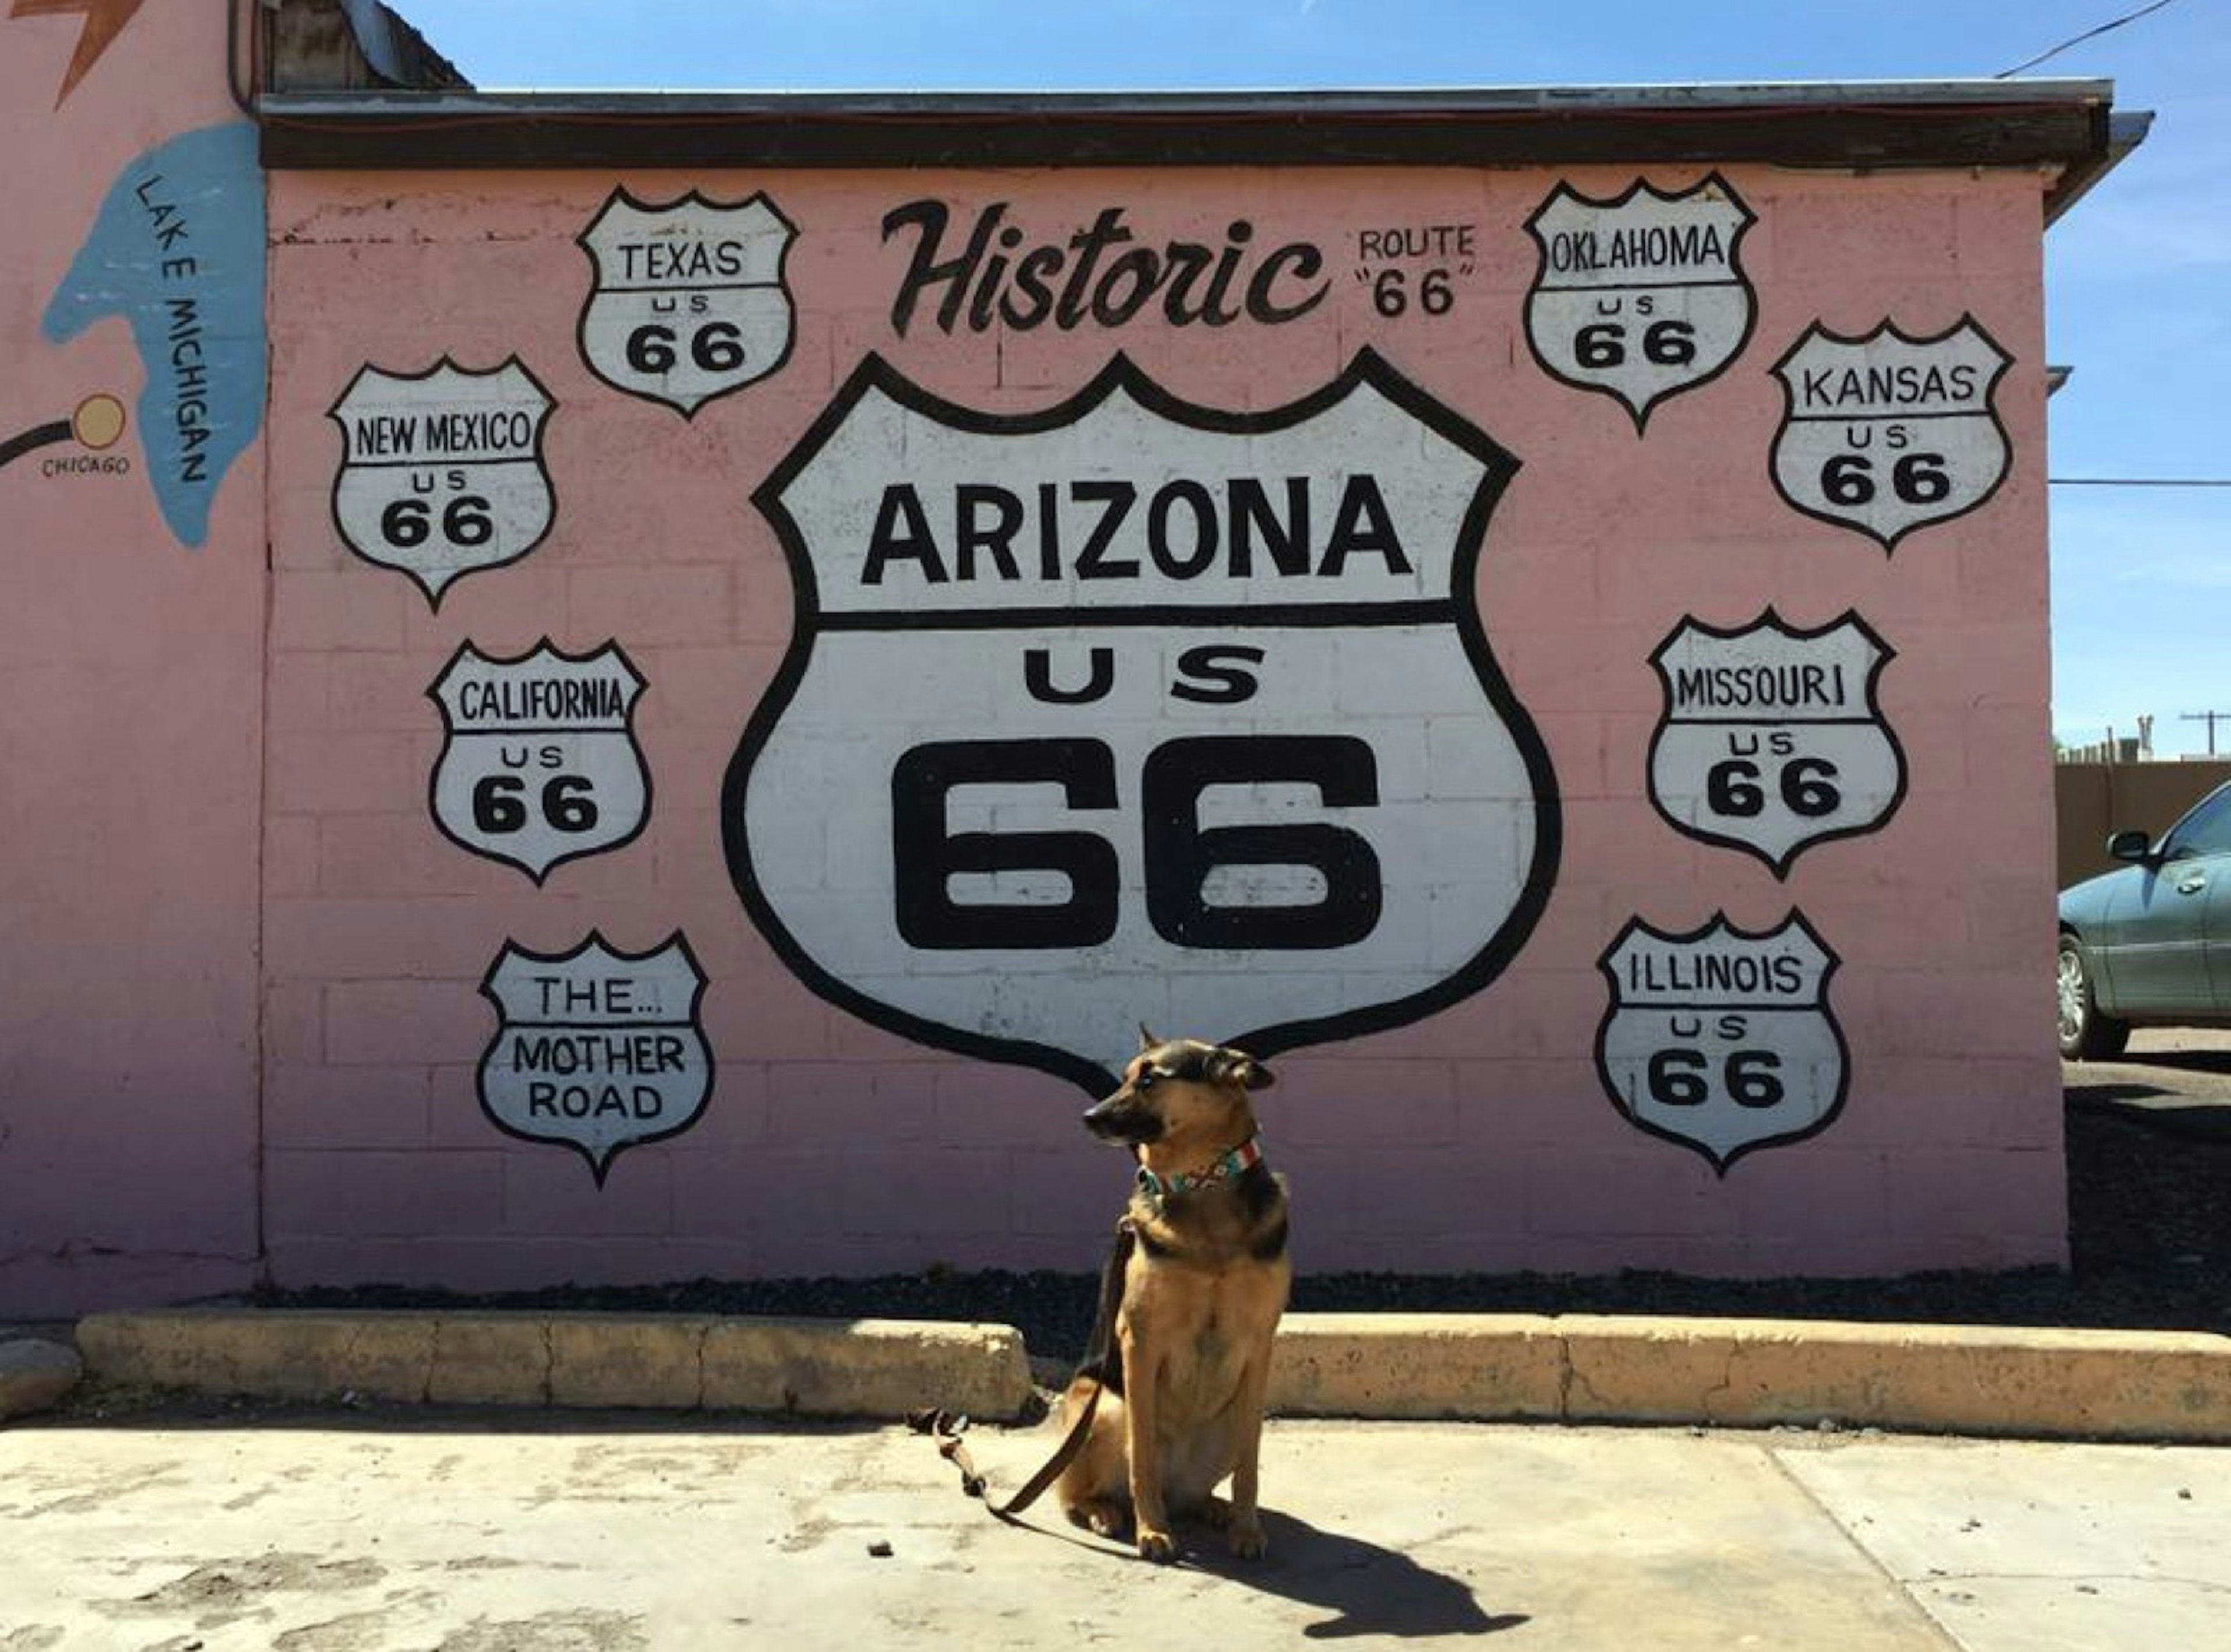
[326,357,558,606]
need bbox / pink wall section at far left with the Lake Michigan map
[0,5,266,1313]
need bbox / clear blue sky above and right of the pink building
[406,0,2231,753]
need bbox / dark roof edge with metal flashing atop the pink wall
[257,80,2146,216]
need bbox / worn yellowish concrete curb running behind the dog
[78,1309,2231,1440]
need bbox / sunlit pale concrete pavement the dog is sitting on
[0,1407,2231,1652]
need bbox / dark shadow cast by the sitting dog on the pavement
[1185,1509,1528,1641]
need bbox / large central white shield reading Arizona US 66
[723,350,1557,1090]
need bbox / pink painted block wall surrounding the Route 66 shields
[256,158,2066,1288]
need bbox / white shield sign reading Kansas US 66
[1774,317,2015,553]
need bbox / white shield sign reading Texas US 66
[580,189,797,419]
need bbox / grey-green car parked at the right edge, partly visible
[2059,785,2231,1061]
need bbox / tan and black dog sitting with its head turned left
[1057,1028,1294,1561]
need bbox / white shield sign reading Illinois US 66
[1595,912,1849,1175]
